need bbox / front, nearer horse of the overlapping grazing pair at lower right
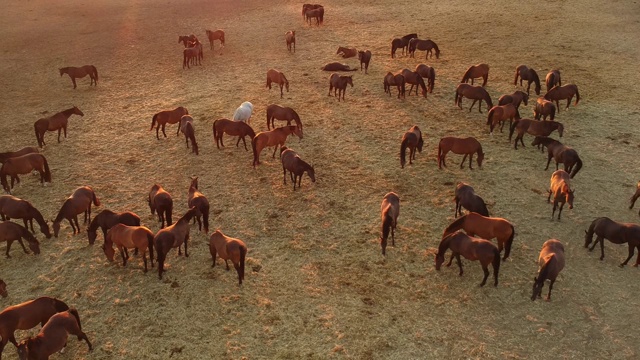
[436,231,500,287]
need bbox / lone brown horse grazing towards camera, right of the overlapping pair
[531,239,564,301]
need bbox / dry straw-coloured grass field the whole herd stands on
[0,0,640,359]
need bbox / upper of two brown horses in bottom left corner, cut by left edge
[0,297,69,356]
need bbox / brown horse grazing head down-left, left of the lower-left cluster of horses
[53,186,100,237]
